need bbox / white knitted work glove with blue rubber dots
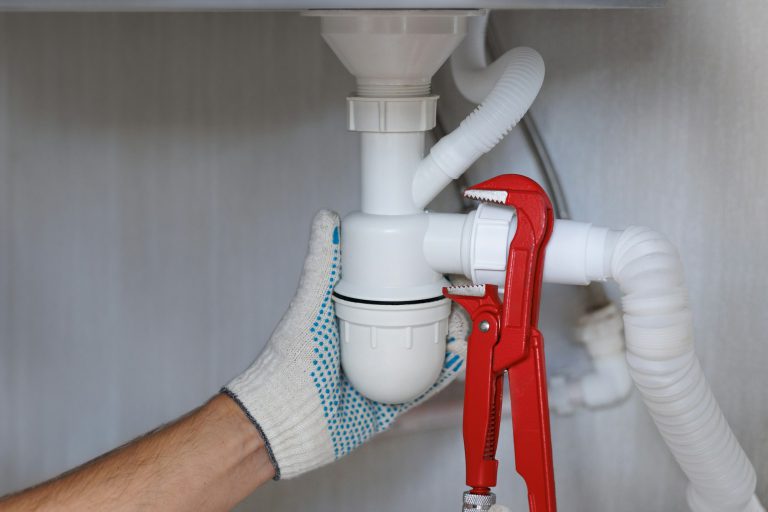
[222,210,469,480]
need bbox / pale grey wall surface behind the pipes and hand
[0,0,768,511]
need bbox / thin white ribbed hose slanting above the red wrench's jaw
[413,47,544,208]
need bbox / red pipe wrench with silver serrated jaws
[443,174,556,512]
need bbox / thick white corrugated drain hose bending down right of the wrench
[611,228,764,512]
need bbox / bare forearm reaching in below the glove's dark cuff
[0,395,274,512]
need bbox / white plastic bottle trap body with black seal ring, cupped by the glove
[334,212,452,403]
